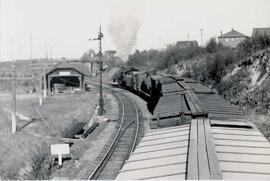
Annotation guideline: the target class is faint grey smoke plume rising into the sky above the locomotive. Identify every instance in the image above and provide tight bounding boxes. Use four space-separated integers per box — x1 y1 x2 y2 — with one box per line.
108 0 144 61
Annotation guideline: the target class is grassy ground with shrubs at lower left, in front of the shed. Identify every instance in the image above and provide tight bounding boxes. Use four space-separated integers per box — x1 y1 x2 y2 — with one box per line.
0 91 97 180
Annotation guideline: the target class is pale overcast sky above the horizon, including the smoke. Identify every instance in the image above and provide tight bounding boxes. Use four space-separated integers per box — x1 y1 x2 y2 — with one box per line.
0 0 270 61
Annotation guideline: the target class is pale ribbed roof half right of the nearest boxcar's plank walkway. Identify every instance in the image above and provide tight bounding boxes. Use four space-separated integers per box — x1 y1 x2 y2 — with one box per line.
211 122 270 180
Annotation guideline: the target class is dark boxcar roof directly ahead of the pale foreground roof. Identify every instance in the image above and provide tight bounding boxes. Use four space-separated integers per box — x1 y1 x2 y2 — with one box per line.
152 74 246 120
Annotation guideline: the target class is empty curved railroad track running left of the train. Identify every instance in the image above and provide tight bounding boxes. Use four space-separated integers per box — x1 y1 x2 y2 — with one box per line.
88 79 140 180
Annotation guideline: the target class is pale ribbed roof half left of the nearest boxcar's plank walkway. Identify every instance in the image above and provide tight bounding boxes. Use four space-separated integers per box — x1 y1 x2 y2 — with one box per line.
116 125 190 180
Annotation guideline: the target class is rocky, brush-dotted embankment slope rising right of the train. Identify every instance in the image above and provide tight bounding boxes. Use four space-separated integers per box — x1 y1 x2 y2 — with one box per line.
178 48 270 139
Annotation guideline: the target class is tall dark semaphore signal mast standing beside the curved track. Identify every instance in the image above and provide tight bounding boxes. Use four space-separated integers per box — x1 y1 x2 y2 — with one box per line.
89 26 104 115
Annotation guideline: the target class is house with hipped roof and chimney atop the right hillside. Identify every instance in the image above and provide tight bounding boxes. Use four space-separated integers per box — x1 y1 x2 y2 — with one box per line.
218 28 248 48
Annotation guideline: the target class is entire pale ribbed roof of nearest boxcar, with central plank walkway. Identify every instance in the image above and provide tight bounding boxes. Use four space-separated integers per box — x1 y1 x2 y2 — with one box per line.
116 119 270 180
